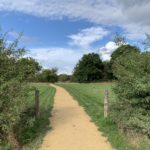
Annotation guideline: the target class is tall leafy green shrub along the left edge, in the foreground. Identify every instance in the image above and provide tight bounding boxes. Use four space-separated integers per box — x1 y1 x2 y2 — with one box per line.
0 32 26 148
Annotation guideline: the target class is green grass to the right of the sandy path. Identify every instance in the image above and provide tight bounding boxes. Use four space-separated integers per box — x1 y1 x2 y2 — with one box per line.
58 83 134 150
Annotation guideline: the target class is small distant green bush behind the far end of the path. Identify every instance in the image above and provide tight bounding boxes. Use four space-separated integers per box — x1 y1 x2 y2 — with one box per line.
37 68 58 83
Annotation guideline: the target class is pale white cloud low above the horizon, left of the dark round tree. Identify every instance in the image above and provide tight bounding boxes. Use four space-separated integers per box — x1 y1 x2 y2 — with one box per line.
26 47 90 74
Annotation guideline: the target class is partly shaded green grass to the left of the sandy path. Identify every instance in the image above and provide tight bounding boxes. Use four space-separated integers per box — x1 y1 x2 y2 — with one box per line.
16 83 55 150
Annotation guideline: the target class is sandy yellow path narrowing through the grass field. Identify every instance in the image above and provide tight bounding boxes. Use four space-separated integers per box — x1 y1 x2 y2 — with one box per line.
40 85 112 150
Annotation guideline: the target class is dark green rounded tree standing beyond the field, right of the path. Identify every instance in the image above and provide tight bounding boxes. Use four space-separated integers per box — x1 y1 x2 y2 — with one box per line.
73 53 103 82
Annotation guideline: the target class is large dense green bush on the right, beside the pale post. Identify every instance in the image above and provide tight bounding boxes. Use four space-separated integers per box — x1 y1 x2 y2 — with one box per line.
112 51 150 136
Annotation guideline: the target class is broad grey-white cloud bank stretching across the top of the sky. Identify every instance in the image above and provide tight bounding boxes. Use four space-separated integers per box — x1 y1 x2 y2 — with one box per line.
0 0 150 39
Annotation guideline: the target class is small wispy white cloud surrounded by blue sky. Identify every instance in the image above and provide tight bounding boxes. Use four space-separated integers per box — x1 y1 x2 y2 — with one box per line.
69 27 109 48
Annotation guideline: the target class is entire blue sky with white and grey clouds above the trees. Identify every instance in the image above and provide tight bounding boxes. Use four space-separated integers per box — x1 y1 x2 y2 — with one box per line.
0 0 150 74
